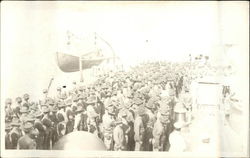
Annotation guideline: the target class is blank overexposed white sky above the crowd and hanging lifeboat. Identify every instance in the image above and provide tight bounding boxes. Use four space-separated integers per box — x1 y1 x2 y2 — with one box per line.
1 1 249 101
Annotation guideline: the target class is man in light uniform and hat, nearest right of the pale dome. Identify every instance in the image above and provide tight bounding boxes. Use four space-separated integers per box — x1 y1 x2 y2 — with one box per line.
113 118 126 151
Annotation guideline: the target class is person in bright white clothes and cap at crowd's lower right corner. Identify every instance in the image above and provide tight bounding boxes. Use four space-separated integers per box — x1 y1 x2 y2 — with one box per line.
169 121 187 152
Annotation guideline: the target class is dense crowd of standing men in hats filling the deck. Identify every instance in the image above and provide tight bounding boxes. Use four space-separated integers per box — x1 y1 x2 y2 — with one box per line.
5 62 232 151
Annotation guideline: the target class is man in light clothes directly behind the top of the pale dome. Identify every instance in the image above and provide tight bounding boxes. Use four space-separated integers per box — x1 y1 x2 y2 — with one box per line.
74 103 88 131
